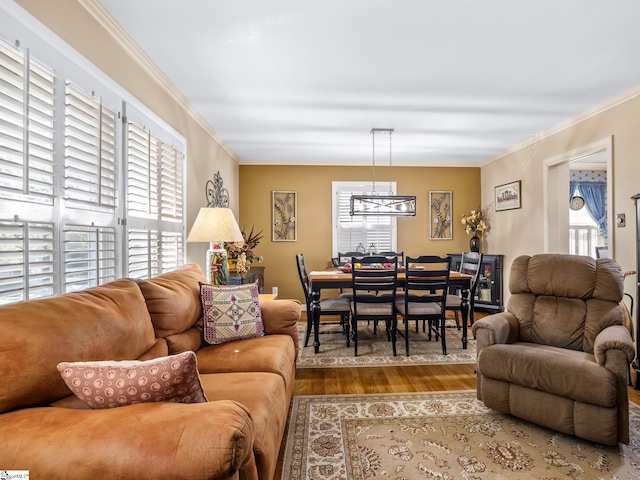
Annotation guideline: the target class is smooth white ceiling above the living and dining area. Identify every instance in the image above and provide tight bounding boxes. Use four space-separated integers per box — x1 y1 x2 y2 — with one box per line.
100 0 640 165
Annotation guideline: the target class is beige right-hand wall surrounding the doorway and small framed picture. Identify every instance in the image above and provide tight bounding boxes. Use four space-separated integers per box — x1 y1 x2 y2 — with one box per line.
482 94 640 304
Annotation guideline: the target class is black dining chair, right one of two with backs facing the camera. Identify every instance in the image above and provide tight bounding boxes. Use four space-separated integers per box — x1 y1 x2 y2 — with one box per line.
395 255 451 356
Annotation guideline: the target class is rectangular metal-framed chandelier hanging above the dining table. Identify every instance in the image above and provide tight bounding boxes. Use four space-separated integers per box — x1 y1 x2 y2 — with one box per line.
349 128 416 217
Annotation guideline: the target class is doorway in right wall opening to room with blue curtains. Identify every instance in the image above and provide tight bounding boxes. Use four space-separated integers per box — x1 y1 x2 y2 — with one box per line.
543 137 614 256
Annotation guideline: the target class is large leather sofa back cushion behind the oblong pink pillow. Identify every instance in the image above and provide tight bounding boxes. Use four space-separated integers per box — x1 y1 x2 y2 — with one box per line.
0 279 156 413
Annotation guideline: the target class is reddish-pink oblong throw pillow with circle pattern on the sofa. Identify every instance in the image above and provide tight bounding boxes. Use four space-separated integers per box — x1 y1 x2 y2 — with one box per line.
57 351 207 409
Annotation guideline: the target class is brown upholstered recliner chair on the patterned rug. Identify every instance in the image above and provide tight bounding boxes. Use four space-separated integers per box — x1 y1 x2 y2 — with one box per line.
473 254 634 445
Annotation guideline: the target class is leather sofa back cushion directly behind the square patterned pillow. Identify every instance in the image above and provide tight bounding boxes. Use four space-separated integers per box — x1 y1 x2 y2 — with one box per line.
136 263 206 337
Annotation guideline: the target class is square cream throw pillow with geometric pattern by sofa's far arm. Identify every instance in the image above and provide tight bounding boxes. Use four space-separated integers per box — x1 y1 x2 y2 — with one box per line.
200 283 264 344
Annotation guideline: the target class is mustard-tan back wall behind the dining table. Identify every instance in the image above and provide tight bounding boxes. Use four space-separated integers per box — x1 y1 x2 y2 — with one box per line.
238 165 480 300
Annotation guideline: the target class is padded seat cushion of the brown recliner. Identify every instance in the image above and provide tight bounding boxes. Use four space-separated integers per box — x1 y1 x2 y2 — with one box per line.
478 342 617 408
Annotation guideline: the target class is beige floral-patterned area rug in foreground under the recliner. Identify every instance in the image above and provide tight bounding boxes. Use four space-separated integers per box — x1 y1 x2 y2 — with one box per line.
282 391 640 480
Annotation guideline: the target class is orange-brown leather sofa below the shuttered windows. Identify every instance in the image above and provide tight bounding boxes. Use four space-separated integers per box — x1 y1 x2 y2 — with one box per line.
0 265 301 480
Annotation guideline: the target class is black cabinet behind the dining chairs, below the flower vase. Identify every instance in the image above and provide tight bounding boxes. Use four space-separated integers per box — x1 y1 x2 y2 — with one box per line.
447 253 504 313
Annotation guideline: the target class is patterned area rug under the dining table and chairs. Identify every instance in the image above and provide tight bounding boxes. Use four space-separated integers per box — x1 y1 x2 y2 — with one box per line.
297 320 476 368
